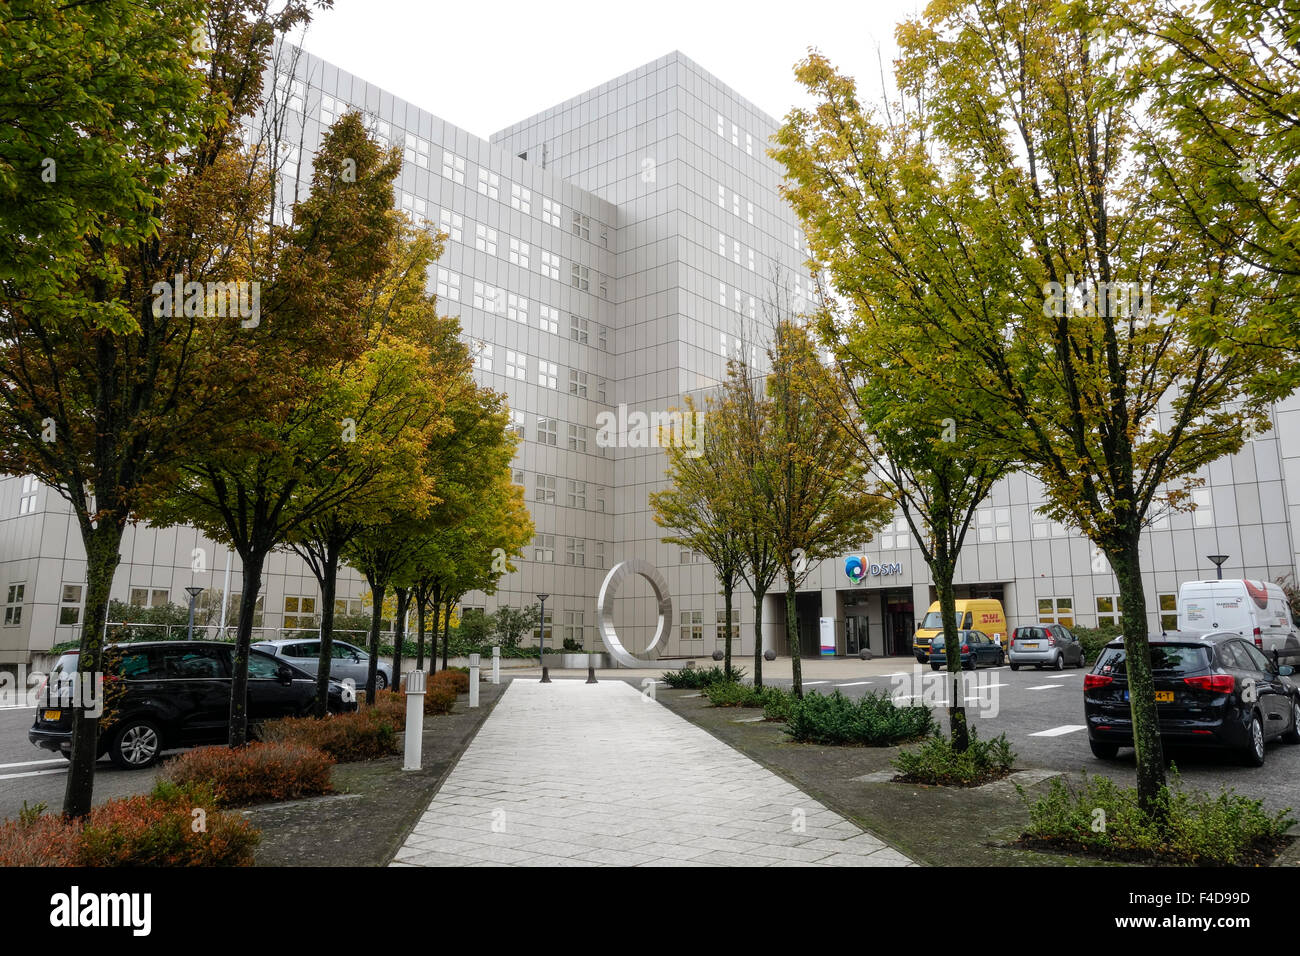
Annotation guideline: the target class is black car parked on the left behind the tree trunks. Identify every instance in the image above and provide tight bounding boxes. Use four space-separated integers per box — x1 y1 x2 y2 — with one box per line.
27 641 356 770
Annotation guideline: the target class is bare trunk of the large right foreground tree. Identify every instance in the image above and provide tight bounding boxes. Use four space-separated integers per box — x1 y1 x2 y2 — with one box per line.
1102 532 1165 814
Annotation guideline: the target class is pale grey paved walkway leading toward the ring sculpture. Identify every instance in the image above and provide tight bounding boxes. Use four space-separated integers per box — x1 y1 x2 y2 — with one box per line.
393 680 914 866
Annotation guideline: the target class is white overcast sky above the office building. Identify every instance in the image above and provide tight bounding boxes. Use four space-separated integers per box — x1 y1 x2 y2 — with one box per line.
300 0 924 138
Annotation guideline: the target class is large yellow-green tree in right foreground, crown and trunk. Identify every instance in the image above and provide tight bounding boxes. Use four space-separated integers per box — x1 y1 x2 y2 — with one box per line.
772 0 1295 809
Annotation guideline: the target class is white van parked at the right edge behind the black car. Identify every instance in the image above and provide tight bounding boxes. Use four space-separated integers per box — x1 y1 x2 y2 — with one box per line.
1178 579 1300 657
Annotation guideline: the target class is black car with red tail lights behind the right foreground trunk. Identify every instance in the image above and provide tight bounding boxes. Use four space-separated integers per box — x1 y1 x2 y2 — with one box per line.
1083 631 1300 766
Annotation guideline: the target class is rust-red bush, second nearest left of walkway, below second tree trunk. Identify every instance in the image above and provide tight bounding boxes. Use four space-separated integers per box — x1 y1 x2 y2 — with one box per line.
161 740 334 806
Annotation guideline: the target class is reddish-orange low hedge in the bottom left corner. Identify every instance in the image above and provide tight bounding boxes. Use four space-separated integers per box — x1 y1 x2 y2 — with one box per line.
0 787 259 866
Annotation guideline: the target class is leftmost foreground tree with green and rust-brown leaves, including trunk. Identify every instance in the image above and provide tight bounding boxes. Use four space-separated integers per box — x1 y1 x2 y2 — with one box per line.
0 0 325 817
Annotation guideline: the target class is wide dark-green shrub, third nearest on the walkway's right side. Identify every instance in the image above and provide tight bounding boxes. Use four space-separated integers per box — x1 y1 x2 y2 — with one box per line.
785 691 937 747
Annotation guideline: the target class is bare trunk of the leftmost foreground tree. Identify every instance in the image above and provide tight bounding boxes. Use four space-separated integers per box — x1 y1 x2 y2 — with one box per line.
64 519 124 819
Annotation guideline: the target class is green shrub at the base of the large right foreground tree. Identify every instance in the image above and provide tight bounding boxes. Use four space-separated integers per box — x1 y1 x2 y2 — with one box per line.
1017 770 1295 866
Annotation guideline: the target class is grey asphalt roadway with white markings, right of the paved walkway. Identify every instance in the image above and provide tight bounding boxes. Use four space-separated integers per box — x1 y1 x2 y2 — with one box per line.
759 658 1300 819
